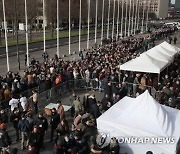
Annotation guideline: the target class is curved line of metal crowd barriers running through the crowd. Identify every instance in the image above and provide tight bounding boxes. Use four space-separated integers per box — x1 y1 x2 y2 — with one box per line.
0 79 159 112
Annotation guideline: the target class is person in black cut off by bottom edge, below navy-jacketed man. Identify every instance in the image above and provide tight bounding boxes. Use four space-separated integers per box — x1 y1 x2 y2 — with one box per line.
28 125 42 154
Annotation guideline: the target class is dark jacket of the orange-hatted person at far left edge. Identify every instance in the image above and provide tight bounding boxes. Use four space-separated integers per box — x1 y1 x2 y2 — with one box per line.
0 130 12 147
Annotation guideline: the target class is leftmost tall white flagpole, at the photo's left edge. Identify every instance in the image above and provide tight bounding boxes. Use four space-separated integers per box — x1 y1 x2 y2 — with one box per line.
2 0 9 72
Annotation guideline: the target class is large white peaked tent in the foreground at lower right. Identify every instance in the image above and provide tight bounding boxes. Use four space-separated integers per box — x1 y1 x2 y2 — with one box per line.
97 91 180 154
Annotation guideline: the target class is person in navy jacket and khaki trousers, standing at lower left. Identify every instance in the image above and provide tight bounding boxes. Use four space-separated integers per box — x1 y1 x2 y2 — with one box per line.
18 113 29 150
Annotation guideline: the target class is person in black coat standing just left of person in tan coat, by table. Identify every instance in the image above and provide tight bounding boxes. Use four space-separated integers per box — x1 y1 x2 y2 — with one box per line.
50 108 60 142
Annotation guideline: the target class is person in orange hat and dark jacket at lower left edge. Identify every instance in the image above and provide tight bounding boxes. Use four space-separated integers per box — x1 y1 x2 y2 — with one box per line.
0 123 12 153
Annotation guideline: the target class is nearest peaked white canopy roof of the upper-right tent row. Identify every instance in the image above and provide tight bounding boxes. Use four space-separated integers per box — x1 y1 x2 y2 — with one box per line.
120 53 167 74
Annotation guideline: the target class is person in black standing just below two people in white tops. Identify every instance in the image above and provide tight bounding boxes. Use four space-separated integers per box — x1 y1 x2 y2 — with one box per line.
10 108 21 142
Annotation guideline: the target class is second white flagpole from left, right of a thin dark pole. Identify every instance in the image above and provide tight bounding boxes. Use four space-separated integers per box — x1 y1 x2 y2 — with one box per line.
25 0 29 67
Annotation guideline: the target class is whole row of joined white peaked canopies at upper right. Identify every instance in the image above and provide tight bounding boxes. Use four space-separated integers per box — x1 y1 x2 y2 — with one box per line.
120 42 180 74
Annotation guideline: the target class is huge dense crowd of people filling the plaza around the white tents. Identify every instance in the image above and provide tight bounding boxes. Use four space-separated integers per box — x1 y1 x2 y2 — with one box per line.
0 25 180 154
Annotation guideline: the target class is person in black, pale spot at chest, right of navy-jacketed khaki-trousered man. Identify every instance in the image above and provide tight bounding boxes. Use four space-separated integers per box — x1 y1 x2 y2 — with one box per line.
35 112 48 146
